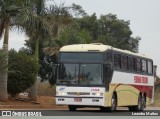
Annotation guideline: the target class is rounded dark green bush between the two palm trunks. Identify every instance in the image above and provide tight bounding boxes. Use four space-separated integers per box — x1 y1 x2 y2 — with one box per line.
7 50 37 96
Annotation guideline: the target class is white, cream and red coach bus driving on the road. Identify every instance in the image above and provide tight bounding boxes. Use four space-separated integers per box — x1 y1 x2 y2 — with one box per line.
56 43 154 111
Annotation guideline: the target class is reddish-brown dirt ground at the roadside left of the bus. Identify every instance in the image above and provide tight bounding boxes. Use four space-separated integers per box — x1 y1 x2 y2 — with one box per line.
0 96 67 109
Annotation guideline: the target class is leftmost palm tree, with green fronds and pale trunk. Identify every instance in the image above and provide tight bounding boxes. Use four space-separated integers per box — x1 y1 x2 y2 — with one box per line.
0 0 39 101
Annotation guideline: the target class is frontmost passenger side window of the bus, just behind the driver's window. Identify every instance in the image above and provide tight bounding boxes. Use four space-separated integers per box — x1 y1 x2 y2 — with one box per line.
114 54 121 69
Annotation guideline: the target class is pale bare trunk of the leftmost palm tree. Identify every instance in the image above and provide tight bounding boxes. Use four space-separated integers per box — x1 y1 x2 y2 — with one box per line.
0 18 10 101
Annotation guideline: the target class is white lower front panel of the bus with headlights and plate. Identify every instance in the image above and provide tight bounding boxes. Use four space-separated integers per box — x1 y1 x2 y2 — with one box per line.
56 86 105 106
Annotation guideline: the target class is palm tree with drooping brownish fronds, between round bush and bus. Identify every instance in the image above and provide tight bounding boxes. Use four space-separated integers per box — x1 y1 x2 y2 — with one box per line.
21 0 86 100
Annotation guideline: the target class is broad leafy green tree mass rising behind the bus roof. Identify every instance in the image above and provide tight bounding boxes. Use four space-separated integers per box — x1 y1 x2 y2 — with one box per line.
76 13 141 52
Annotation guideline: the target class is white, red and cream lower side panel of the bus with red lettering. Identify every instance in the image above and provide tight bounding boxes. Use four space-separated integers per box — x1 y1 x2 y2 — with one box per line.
105 71 154 107
